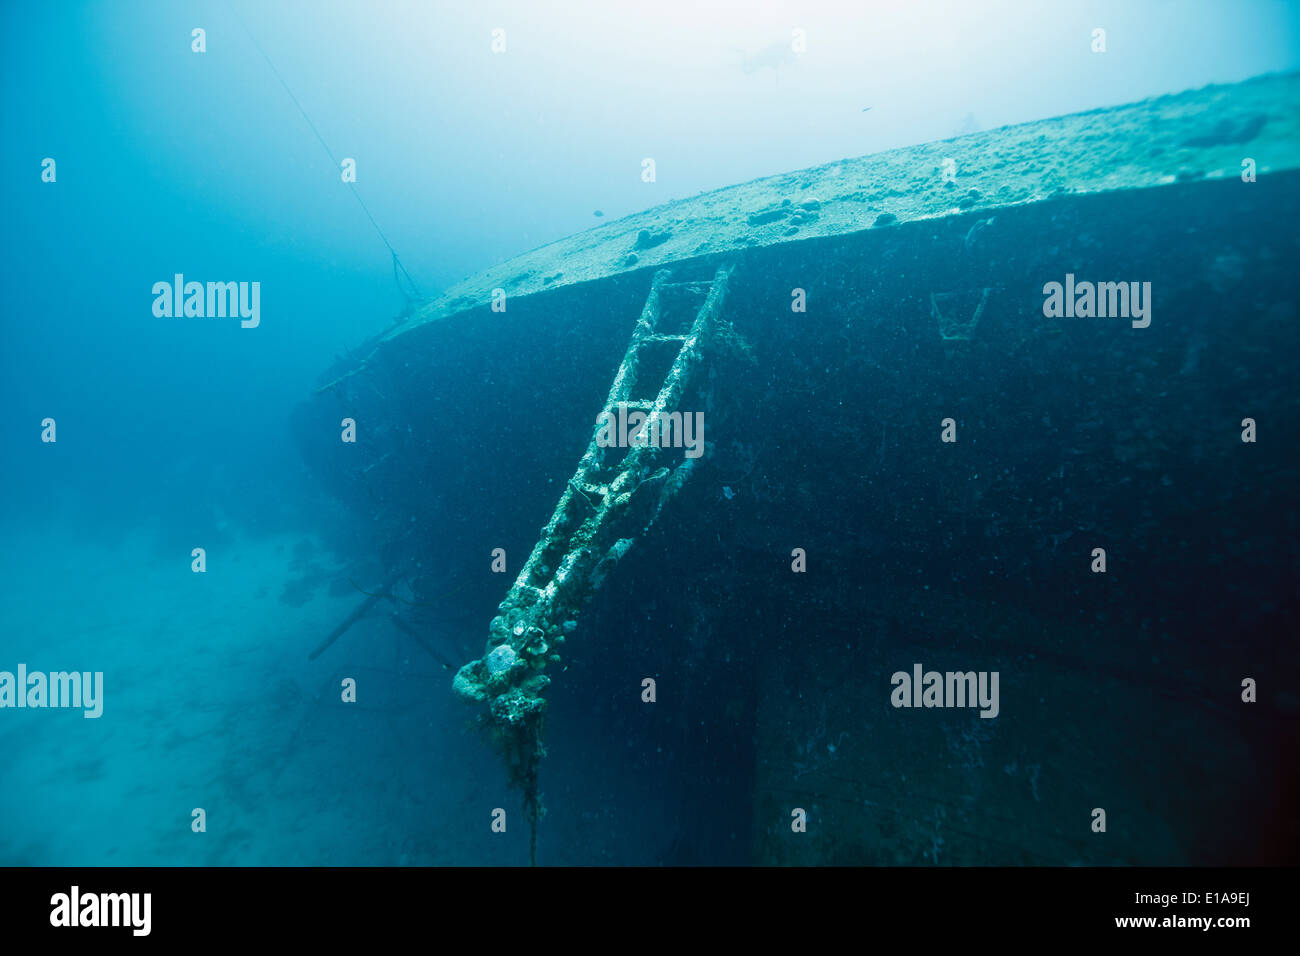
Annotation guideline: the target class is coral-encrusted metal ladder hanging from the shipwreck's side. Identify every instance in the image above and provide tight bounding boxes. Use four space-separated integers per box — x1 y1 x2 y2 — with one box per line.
454 265 732 858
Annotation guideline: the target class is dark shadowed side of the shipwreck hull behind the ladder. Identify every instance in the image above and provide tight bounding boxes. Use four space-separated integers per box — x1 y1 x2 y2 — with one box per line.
300 81 1300 865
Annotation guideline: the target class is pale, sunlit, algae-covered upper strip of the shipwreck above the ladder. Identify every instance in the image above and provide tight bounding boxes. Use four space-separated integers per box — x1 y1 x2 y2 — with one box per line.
321 73 1300 390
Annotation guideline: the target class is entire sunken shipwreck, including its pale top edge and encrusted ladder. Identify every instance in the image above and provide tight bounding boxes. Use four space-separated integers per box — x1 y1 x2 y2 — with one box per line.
304 75 1300 865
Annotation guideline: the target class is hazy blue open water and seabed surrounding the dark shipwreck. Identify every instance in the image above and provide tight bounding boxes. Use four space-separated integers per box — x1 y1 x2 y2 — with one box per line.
0 0 1300 865
